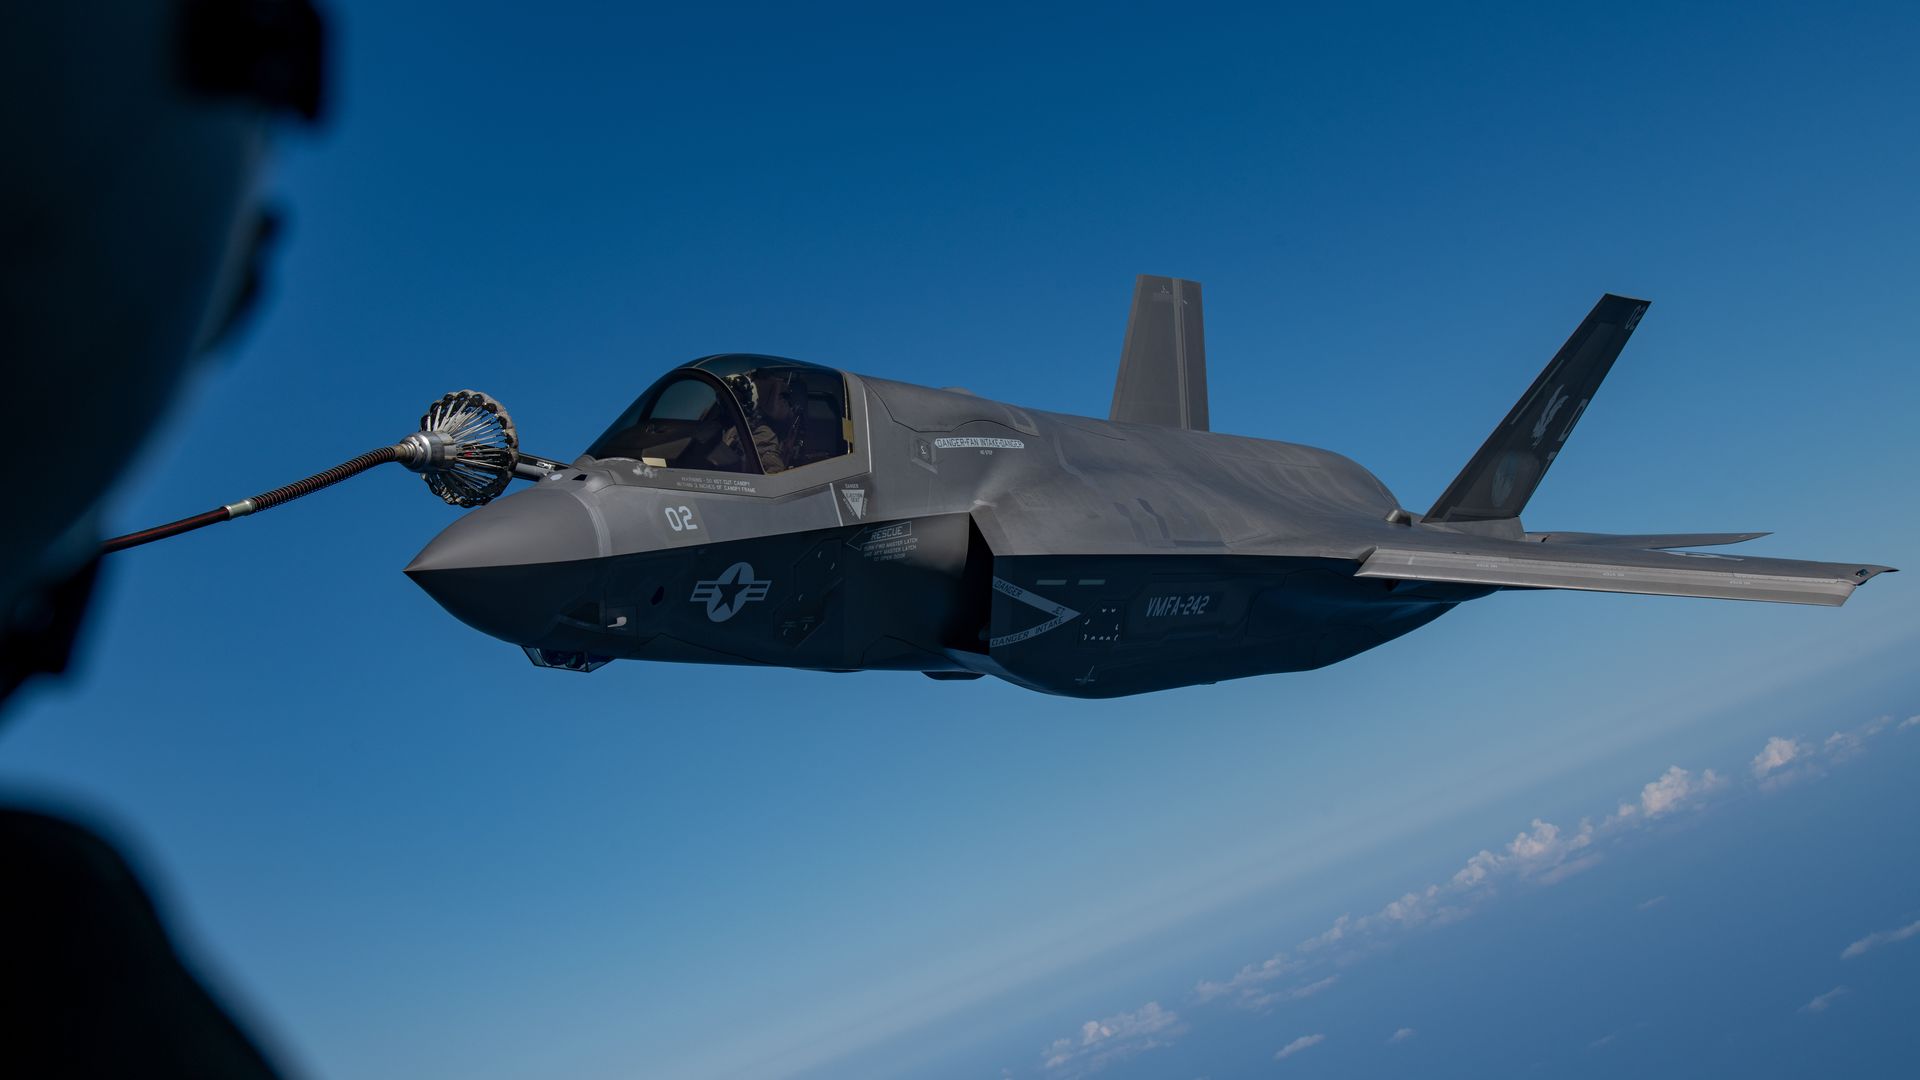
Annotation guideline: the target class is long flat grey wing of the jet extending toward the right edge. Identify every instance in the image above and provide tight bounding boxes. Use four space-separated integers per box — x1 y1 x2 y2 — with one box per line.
1357 540 1893 607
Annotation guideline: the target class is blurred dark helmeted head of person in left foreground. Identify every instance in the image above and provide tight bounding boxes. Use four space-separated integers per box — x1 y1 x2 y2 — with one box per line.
0 0 323 696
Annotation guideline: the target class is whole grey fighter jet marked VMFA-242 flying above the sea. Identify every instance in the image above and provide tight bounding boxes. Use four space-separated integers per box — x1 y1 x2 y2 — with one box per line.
407 277 1891 698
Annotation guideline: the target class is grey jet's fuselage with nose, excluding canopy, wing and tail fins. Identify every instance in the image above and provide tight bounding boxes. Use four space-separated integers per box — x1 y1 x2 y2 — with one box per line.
407 361 1490 698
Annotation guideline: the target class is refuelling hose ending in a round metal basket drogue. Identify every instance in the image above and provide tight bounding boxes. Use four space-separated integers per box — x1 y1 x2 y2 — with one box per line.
100 390 564 553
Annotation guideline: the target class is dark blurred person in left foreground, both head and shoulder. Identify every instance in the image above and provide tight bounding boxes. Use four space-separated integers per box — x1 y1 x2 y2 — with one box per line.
0 0 324 1080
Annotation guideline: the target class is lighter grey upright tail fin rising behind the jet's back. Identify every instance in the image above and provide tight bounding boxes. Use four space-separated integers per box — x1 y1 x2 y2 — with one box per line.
1108 273 1208 430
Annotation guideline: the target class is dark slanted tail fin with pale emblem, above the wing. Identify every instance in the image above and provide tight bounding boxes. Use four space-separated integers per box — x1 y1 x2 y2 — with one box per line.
1427 292 1647 523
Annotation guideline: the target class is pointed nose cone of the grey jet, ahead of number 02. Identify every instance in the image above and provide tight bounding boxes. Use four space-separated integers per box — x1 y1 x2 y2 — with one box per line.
405 486 601 646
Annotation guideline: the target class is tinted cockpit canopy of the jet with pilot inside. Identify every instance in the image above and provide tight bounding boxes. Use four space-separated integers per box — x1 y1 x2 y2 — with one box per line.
588 354 852 475
